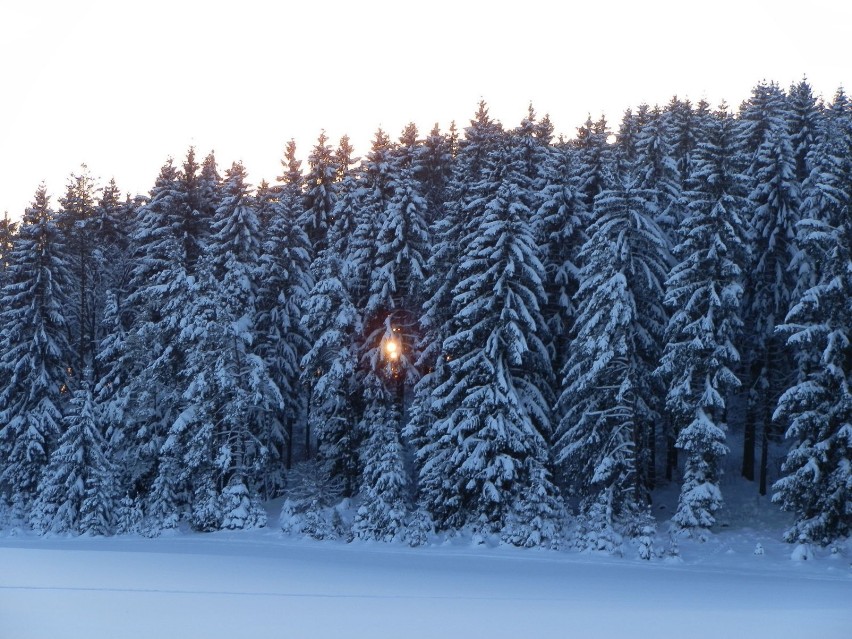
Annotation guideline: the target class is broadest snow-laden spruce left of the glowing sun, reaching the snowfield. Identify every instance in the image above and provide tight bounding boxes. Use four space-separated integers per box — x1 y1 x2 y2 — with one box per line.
174 163 276 529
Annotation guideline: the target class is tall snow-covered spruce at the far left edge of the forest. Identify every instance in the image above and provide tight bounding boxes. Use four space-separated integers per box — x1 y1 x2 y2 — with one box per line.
0 185 72 520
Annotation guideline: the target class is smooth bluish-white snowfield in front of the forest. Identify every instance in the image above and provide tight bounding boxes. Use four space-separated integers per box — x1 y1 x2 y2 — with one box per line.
0 529 852 639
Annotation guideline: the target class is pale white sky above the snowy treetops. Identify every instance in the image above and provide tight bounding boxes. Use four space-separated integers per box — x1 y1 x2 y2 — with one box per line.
0 0 852 217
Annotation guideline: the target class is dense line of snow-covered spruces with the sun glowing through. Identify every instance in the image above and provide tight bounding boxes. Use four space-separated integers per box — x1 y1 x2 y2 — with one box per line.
0 81 852 550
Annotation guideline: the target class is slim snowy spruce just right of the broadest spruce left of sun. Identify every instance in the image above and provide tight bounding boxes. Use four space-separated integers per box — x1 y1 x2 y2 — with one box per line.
258 140 313 480
